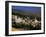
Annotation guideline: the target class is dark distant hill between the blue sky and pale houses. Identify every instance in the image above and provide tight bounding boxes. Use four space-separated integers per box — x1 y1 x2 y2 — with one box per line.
12 10 41 17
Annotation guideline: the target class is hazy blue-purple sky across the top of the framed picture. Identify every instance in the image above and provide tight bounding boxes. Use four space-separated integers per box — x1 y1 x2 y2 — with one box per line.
12 6 41 12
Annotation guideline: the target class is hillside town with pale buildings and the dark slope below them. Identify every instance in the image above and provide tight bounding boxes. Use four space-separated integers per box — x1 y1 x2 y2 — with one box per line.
12 15 41 30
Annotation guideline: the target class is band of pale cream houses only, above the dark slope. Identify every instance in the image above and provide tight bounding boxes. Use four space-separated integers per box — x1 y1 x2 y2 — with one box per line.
12 15 41 27
